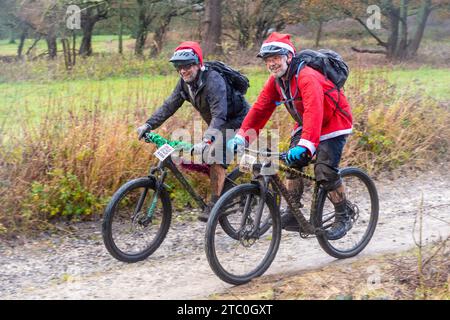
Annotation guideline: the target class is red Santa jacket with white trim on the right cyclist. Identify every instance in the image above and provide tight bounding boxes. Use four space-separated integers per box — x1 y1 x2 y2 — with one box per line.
238 66 353 155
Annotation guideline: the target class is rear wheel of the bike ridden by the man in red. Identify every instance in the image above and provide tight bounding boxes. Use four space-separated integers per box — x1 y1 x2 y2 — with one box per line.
314 168 379 259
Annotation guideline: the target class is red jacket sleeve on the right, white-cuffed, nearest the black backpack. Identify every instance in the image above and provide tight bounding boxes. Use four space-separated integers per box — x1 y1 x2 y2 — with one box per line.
298 75 324 155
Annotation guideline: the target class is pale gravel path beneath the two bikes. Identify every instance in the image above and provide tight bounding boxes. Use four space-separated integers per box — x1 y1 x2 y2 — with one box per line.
0 166 450 299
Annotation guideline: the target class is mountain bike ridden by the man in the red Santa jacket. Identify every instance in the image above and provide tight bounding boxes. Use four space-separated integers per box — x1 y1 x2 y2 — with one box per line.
205 148 379 285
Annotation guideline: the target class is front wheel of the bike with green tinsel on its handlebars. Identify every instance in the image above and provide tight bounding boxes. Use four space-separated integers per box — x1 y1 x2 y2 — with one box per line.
102 177 172 263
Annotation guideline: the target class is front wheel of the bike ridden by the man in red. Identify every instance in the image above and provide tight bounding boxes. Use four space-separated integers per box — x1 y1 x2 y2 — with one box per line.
205 184 281 285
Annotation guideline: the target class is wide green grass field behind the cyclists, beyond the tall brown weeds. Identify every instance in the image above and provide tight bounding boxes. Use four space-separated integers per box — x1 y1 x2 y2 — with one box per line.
0 67 450 132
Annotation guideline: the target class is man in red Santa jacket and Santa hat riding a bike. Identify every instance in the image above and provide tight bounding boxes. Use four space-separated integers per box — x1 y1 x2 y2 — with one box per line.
228 32 352 240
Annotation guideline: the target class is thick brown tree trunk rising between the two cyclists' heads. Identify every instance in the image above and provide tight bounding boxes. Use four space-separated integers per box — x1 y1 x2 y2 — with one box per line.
203 0 222 55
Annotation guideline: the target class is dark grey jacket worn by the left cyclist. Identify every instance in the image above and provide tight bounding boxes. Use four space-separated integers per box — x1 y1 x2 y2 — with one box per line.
147 69 250 139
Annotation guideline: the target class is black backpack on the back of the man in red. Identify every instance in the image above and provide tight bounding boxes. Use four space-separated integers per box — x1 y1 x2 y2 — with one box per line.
296 49 349 90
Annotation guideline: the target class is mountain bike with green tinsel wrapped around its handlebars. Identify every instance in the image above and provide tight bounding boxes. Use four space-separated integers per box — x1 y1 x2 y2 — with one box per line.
102 132 241 263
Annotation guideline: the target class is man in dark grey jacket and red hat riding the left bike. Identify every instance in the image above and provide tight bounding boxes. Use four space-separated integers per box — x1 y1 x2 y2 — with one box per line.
138 41 250 221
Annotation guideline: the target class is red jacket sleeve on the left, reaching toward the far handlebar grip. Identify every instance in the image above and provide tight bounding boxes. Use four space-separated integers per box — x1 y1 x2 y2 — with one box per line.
237 76 280 142
